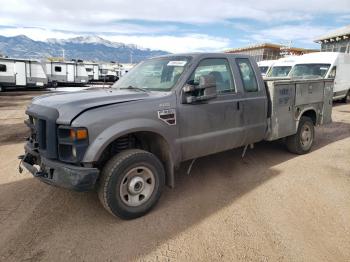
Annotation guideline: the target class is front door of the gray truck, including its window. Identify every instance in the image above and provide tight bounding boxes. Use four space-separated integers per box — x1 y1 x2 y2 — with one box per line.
178 58 243 160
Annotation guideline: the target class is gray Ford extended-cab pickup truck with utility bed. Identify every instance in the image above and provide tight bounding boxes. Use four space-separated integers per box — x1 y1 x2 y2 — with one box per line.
20 53 333 219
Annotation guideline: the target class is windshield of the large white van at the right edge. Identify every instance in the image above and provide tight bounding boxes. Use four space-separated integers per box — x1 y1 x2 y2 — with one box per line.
291 64 331 78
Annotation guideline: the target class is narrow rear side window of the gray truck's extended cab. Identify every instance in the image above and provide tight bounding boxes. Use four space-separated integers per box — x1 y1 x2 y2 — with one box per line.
236 58 258 92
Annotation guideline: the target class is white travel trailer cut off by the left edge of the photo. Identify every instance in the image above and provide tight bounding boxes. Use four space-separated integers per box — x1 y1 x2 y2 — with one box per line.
0 58 47 91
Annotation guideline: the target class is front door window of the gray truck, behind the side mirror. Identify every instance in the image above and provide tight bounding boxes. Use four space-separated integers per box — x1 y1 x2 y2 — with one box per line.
189 58 235 93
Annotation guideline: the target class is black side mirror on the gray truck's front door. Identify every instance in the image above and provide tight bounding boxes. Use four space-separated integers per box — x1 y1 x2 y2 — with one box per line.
183 75 217 104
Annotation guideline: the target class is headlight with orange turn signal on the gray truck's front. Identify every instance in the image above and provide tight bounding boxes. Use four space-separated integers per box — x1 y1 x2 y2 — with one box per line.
57 126 89 163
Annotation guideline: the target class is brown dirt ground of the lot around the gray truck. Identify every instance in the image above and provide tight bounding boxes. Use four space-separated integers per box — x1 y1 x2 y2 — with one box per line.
0 92 350 261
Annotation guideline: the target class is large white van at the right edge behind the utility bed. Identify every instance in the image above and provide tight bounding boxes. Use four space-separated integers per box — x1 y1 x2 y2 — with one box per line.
290 52 350 102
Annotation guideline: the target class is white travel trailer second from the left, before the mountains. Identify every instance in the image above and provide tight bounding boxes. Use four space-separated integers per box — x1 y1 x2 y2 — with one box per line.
45 61 89 87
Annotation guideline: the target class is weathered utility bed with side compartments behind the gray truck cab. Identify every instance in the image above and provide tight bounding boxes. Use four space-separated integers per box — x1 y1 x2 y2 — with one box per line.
265 79 334 141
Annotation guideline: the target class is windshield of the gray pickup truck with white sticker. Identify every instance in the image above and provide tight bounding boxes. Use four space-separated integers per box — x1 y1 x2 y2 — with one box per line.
112 56 190 91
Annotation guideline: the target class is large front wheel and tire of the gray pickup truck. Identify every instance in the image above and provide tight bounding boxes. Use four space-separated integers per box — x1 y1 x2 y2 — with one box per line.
98 149 165 219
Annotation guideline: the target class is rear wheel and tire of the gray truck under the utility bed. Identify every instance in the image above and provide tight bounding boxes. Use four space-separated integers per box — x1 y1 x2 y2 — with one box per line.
286 116 315 155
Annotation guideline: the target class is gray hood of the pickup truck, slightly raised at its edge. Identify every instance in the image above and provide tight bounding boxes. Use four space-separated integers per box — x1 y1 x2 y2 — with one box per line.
27 89 164 125
